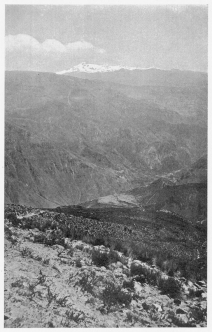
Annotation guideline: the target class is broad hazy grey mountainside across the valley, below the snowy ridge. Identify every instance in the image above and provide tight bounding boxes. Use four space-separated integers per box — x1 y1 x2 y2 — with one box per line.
5 72 207 207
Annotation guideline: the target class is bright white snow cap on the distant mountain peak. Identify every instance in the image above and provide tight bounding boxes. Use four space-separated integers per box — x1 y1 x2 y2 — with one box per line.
57 62 156 75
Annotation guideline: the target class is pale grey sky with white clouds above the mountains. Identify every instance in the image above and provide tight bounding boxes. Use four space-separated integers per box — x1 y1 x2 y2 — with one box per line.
5 5 208 72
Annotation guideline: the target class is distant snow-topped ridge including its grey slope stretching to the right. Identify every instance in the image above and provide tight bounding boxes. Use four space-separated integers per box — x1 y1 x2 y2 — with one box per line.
56 62 207 88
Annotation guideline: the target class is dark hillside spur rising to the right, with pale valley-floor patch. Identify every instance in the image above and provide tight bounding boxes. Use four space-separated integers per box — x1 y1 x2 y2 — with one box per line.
71 156 207 223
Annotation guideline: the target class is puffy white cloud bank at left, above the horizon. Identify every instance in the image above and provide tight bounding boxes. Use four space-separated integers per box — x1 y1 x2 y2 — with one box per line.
5 34 106 71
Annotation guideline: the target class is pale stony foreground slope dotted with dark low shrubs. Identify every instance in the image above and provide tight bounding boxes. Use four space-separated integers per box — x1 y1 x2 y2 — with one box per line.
4 205 207 328
